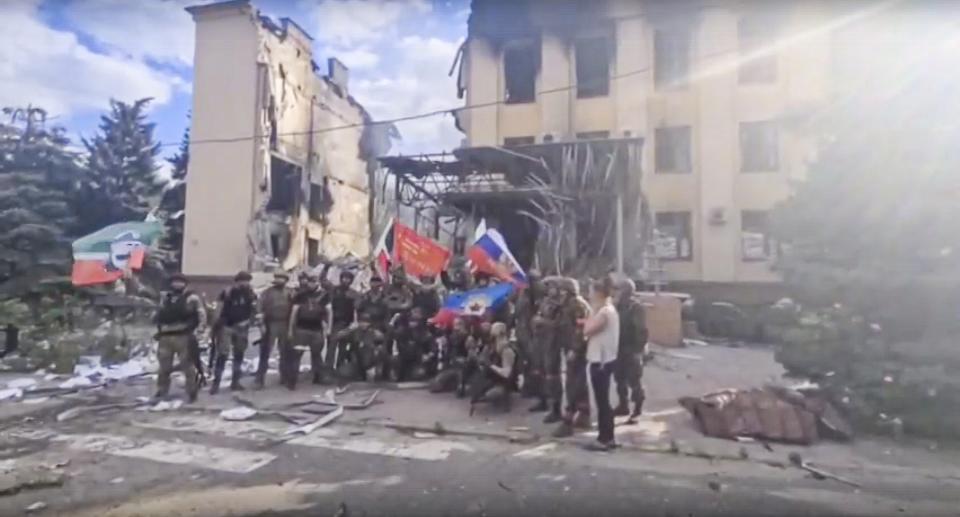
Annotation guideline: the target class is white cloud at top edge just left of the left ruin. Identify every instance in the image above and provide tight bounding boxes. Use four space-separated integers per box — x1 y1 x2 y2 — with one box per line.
64 0 205 66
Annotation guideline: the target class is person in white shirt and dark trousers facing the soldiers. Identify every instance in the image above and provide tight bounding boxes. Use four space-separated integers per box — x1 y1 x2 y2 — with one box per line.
583 277 620 451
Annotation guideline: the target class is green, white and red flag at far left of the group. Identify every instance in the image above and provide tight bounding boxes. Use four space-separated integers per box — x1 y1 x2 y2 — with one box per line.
71 221 163 286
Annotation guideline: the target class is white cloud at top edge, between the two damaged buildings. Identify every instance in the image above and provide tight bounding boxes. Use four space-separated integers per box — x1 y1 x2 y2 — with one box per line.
301 0 431 46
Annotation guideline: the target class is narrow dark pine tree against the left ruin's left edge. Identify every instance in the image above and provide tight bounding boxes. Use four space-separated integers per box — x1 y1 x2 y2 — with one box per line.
157 121 190 271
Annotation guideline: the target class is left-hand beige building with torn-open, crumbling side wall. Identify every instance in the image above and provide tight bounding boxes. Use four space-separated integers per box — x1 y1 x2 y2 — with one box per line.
183 0 386 283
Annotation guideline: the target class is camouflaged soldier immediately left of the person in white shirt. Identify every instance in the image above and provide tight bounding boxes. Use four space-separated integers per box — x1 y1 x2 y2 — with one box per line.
554 278 590 437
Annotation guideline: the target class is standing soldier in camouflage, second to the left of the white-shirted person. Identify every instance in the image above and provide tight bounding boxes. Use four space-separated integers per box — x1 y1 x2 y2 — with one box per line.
530 282 563 424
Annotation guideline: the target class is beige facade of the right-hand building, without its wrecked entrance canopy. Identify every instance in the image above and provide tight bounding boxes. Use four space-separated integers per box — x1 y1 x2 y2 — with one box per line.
458 0 831 283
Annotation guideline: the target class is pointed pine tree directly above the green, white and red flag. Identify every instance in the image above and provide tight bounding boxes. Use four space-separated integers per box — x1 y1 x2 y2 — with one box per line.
75 98 163 234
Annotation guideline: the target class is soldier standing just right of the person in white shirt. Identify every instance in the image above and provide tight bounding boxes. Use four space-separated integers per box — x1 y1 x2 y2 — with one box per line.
613 278 647 421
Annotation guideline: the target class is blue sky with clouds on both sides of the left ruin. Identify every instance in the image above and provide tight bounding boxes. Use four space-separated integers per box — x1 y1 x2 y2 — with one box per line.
0 0 469 175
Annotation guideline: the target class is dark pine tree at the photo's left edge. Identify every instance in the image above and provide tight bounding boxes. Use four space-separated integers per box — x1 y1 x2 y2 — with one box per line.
0 106 80 299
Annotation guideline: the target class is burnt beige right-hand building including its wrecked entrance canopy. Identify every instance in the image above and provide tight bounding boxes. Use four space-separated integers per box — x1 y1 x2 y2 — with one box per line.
387 0 831 286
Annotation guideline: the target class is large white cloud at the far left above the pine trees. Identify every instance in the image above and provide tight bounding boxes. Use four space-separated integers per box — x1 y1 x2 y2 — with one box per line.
0 0 187 115
